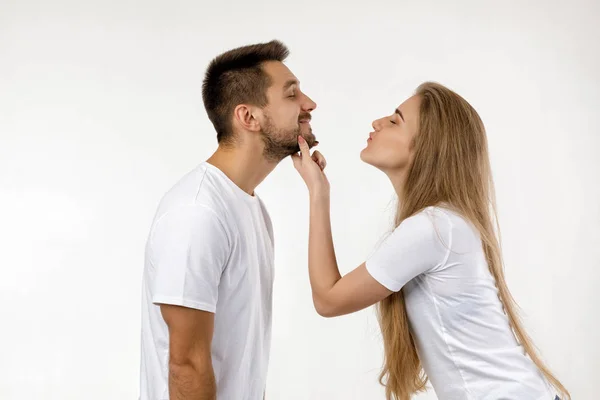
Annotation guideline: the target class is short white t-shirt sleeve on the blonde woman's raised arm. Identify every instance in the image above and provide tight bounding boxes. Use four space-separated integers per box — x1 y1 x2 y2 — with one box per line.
366 211 451 292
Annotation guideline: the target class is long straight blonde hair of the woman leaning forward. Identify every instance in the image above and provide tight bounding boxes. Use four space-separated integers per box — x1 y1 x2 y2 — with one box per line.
378 82 571 400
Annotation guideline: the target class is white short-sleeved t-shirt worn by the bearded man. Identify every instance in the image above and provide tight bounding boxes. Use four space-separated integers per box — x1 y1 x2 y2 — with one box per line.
140 162 274 400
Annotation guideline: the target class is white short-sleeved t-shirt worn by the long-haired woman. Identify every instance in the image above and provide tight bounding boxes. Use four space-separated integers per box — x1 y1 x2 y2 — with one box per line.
366 207 554 400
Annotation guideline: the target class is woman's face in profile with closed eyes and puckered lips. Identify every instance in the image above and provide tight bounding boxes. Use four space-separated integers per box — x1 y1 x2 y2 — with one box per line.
360 96 421 174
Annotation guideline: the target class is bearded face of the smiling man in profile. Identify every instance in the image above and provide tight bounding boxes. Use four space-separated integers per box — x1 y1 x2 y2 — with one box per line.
261 61 317 161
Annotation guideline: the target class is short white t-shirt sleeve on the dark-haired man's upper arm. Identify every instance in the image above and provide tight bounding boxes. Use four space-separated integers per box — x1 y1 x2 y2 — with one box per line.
150 206 230 313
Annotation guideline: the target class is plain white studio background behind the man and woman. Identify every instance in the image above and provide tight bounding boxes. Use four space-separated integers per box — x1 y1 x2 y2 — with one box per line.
0 0 600 400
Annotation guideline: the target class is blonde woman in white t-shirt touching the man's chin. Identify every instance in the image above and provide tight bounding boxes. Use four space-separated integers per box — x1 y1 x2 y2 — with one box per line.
292 83 570 400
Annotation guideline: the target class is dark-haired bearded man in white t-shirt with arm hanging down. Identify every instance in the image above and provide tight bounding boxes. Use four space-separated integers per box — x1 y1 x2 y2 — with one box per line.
140 41 319 400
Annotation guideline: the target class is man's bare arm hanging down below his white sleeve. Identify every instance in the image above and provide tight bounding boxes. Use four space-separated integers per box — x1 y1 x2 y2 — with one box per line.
160 304 217 400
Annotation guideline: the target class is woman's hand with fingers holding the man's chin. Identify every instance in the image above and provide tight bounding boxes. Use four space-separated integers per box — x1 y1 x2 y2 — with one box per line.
292 136 329 196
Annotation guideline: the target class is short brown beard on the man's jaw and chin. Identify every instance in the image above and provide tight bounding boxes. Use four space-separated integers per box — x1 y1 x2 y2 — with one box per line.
261 111 316 162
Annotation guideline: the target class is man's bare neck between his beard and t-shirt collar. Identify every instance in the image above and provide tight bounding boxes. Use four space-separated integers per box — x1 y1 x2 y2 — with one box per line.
206 146 279 196
